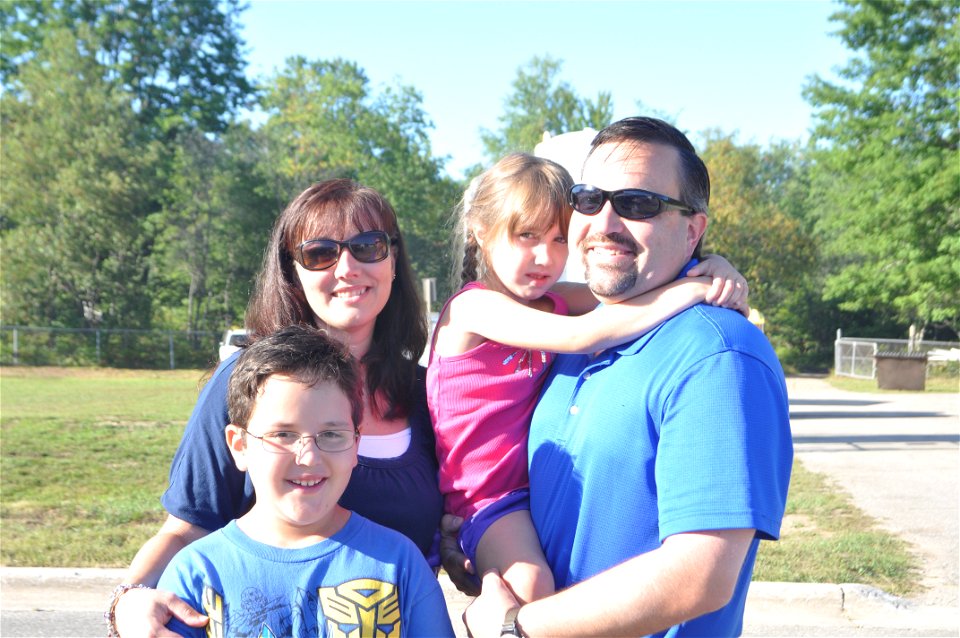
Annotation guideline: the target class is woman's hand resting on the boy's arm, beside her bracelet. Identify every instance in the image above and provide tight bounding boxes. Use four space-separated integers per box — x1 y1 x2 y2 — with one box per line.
114 589 207 638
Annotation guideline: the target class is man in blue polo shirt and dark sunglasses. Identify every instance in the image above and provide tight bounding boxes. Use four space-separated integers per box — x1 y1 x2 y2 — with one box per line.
465 118 793 638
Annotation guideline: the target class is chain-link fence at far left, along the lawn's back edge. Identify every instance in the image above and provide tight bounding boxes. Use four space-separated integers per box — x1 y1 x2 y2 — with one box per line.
0 326 220 370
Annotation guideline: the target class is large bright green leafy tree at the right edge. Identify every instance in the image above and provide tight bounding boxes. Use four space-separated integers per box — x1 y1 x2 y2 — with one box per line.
805 0 960 338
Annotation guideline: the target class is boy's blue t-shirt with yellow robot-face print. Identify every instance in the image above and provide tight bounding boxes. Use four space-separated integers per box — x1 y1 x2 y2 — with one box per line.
157 513 453 638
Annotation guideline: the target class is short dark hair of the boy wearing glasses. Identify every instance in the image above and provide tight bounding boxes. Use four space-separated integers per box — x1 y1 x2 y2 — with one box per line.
227 326 363 430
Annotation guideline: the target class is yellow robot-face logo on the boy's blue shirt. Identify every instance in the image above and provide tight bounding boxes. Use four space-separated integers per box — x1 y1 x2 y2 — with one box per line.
317 578 400 638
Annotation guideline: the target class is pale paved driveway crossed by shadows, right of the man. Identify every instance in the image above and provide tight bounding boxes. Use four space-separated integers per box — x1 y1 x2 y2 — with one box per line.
788 378 960 608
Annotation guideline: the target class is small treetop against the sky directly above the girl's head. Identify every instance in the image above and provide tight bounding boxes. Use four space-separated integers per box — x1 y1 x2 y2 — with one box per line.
480 56 613 162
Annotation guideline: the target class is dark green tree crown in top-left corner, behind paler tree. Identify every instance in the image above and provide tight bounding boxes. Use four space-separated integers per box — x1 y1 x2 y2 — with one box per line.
0 0 252 132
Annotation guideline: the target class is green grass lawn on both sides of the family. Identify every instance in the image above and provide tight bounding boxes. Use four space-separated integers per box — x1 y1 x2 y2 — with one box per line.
0 368 919 594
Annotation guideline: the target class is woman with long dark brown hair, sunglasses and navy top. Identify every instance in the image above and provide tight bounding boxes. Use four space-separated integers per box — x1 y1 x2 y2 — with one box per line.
108 179 442 634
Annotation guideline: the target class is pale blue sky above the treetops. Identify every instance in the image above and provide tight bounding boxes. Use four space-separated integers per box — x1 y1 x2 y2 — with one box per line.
242 0 852 177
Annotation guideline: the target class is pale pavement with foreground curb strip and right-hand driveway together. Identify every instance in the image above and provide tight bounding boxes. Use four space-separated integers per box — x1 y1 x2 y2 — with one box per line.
0 378 960 637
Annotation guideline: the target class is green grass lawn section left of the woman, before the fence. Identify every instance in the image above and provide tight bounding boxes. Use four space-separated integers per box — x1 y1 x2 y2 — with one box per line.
0 368 203 567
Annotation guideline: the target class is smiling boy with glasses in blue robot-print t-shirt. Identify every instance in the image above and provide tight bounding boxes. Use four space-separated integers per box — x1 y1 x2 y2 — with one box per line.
158 327 453 636
